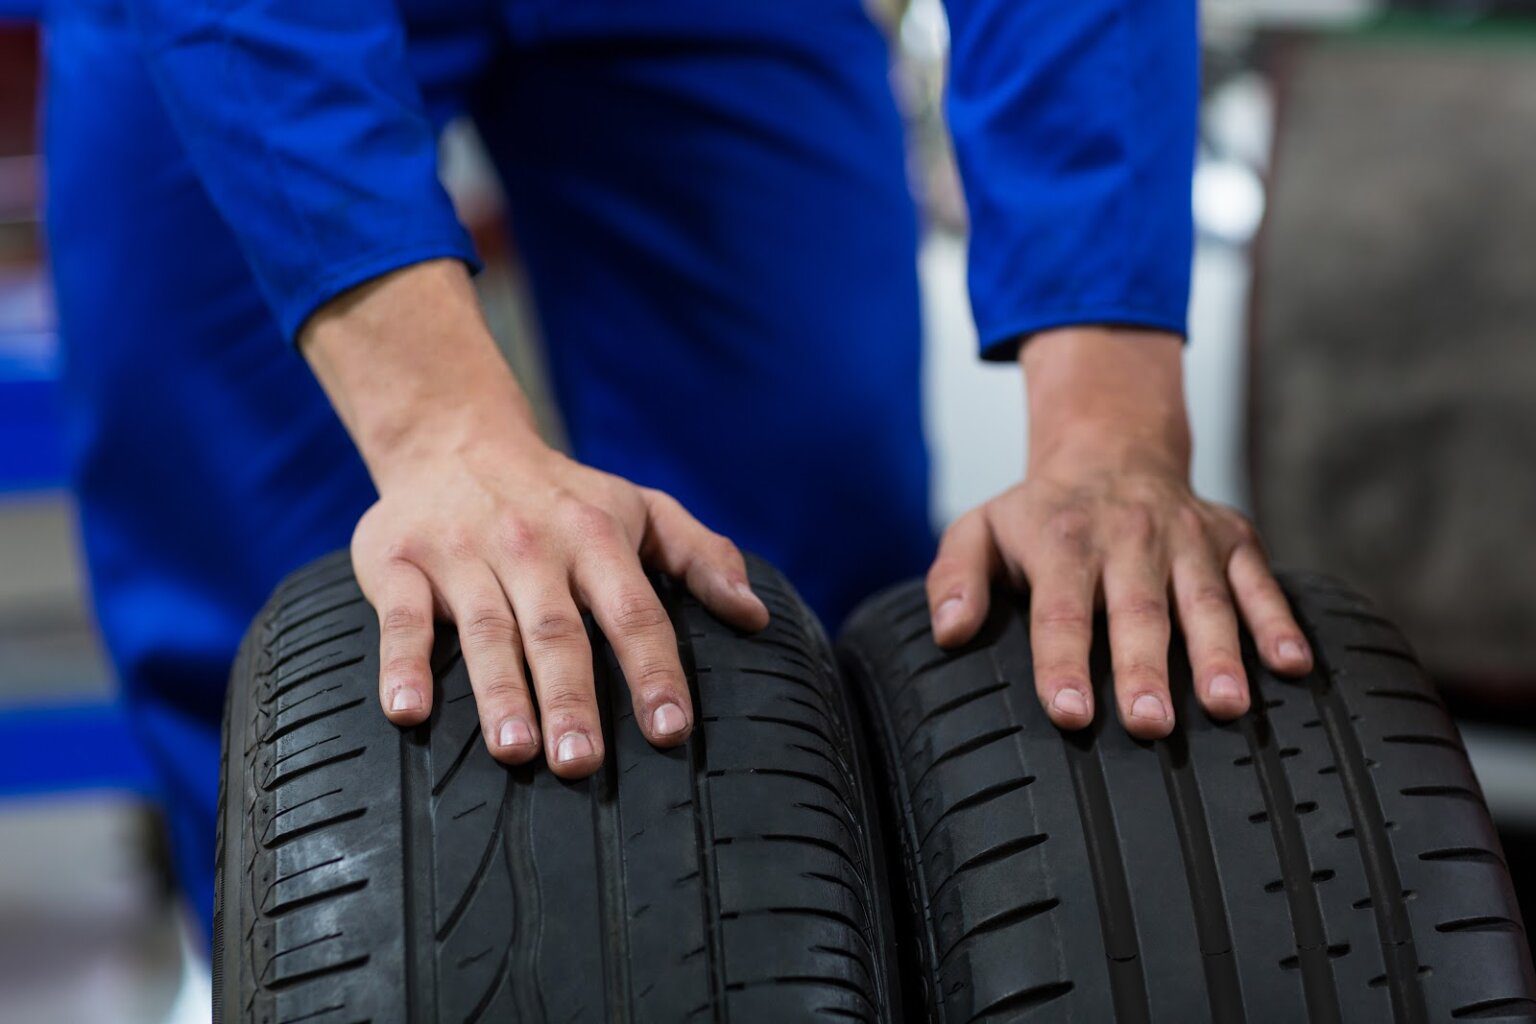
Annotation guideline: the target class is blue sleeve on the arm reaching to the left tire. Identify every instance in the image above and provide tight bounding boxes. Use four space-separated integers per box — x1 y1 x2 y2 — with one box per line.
123 0 475 339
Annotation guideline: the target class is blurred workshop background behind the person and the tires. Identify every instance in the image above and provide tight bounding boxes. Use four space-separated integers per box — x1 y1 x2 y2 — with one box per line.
0 0 1536 1024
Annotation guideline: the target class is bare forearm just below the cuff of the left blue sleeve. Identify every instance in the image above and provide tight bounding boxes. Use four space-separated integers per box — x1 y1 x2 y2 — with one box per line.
300 259 541 487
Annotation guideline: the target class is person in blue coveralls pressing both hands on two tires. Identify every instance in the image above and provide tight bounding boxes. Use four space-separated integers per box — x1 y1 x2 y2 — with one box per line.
48 0 1310 939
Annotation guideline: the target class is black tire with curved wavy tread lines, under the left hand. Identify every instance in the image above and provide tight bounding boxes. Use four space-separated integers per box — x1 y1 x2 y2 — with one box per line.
214 554 894 1024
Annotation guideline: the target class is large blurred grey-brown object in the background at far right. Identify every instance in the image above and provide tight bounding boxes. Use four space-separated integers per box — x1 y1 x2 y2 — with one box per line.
1252 28 1536 687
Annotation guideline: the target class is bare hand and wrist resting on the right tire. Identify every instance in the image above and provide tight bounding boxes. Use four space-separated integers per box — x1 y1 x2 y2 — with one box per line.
928 329 1312 738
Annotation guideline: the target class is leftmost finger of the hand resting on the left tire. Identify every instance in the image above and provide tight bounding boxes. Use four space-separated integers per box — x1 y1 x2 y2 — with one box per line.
373 562 432 726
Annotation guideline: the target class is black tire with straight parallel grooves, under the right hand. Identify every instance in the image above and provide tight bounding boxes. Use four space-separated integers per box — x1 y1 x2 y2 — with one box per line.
839 577 1536 1024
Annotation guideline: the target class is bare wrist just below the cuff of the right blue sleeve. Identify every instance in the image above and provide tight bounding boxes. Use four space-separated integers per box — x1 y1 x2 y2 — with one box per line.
1018 327 1190 474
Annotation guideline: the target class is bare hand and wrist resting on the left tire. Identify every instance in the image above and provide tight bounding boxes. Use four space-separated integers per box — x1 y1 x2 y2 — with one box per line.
301 263 768 778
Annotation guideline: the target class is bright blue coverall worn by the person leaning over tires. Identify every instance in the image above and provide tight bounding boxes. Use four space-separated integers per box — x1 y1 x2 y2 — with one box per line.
45 0 1197 939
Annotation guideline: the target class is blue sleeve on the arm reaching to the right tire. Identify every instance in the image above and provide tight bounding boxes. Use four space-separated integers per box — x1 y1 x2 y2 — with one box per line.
948 0 1200 359
